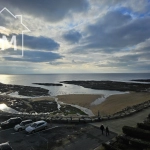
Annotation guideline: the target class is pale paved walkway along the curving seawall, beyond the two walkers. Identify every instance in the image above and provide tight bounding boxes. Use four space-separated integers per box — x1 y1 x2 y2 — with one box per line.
91 108 150 134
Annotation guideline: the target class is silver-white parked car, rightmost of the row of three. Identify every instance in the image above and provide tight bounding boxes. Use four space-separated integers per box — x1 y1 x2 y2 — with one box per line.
25 120 47 133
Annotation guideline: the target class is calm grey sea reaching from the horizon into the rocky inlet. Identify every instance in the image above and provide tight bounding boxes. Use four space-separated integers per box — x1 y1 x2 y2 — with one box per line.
0 73 150 97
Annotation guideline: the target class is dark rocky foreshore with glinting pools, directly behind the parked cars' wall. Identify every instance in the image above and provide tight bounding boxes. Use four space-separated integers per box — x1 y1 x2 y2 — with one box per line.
0 95 89 116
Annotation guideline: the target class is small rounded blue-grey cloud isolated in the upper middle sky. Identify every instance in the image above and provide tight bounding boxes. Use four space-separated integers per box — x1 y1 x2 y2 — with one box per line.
63 30 82 44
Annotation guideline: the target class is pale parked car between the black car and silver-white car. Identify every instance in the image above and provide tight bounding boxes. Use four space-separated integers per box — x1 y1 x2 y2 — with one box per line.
14 120 33 131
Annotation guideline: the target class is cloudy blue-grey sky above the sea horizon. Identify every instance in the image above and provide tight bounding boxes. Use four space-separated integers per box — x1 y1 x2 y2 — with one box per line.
0 0 150 74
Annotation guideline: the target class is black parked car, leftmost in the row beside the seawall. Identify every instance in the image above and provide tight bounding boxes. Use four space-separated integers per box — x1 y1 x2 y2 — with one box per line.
0 117 22 129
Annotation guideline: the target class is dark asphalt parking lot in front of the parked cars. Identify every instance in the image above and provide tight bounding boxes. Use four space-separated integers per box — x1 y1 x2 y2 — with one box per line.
0 124 116 150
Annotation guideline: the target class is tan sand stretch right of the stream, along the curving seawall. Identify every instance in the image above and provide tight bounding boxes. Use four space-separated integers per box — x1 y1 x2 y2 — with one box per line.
91 92 150 115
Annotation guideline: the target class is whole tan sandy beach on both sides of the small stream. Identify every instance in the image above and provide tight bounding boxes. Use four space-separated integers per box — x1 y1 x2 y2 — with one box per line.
57 92 150 115
